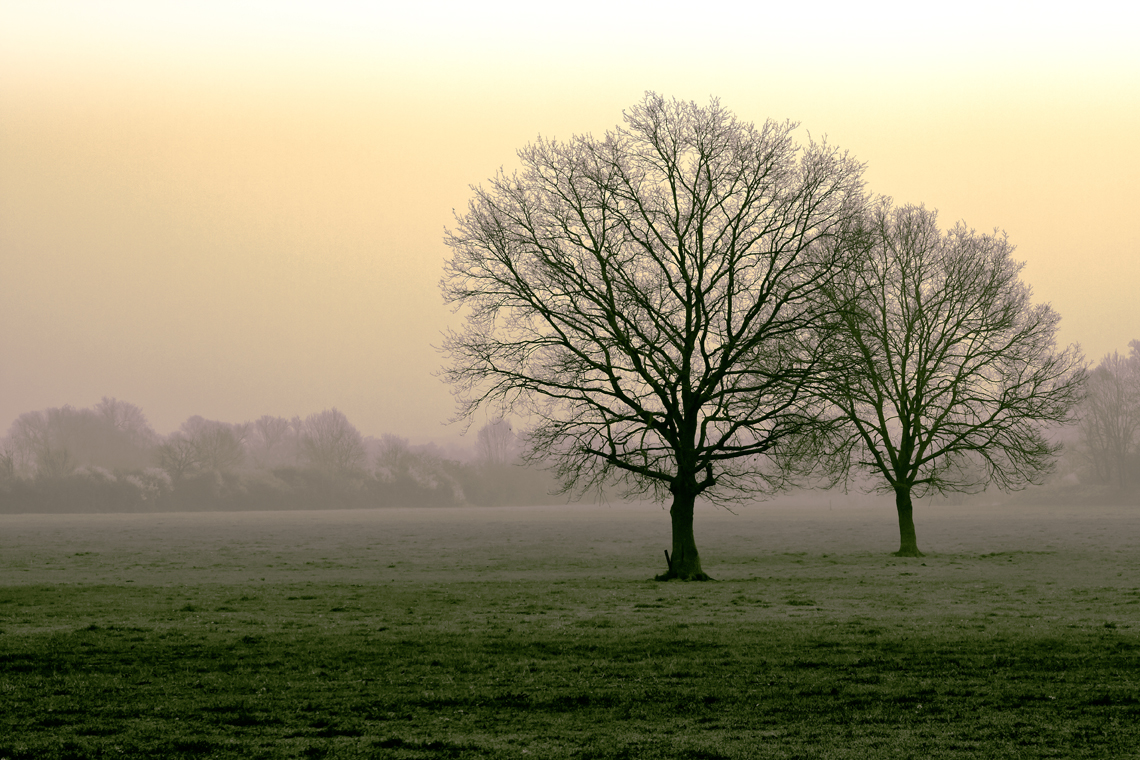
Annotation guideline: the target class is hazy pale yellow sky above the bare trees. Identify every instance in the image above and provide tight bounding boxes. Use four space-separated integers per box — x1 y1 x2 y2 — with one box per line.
0 0 1140 439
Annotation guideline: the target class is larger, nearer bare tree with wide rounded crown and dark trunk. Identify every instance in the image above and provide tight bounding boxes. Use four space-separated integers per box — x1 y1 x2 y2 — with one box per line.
441 93 863 579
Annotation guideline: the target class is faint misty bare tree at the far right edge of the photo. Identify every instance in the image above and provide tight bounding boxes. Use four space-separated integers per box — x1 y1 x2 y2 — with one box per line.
1081 348 1140 491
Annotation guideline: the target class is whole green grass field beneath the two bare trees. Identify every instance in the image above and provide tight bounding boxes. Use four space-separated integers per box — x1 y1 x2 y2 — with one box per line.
0 504 1140 760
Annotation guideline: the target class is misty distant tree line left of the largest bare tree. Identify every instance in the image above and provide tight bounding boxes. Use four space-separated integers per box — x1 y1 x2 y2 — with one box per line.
0 398 557 513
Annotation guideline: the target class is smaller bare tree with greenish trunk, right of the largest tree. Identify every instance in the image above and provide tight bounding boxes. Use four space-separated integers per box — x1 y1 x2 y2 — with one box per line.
821 201 1084 556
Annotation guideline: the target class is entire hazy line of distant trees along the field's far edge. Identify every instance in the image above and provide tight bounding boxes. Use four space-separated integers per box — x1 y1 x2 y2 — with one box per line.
0 340 1140 513
